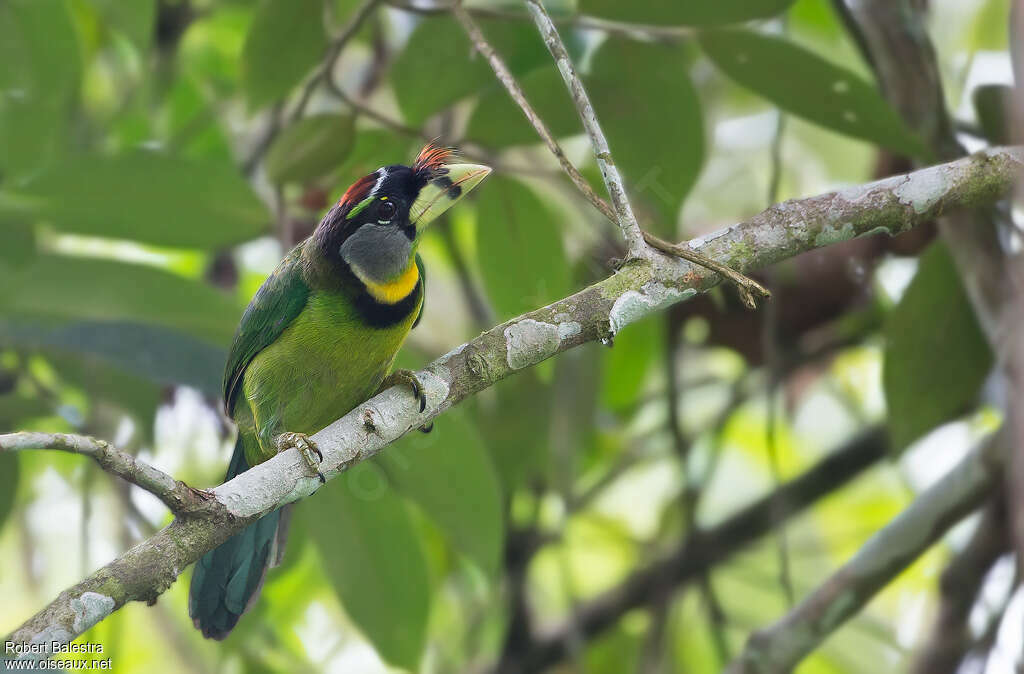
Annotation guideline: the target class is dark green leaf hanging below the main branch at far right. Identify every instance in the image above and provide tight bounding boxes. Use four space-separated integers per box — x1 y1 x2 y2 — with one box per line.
883 243 992 450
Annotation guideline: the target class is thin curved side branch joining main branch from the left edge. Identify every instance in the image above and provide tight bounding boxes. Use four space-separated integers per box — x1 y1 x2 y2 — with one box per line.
0 432 207 515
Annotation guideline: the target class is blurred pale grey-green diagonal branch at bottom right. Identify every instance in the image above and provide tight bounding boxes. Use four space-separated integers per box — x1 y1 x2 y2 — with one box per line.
726 432 1005 674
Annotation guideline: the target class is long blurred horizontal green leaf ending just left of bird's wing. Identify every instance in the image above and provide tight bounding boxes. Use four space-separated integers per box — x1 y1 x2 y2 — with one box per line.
0 255 242 344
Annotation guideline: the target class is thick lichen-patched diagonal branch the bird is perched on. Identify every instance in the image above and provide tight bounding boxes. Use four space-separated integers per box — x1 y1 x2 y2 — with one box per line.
8 148 1024 655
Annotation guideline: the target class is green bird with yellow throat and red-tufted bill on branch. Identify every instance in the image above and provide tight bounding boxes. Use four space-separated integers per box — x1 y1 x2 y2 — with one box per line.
188 142 490 639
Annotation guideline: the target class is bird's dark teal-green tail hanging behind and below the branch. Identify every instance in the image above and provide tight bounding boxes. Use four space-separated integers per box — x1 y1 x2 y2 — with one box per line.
188 437 287 639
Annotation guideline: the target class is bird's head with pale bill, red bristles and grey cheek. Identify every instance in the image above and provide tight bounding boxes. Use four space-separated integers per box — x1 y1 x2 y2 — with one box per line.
313 144 490 284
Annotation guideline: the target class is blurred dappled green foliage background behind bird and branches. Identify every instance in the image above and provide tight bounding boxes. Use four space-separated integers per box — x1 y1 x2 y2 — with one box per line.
0 0 1019 674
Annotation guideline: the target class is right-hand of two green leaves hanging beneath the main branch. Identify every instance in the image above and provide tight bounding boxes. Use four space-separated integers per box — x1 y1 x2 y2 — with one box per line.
378 411 505 576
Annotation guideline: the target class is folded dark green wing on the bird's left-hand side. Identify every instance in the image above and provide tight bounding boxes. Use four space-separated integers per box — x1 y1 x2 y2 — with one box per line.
224 244 310 409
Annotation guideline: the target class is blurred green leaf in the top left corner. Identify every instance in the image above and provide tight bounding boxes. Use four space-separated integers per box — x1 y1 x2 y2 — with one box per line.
0 0 81 177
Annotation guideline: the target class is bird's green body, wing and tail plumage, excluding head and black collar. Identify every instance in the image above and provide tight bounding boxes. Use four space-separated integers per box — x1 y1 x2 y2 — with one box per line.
189 242 424 638
